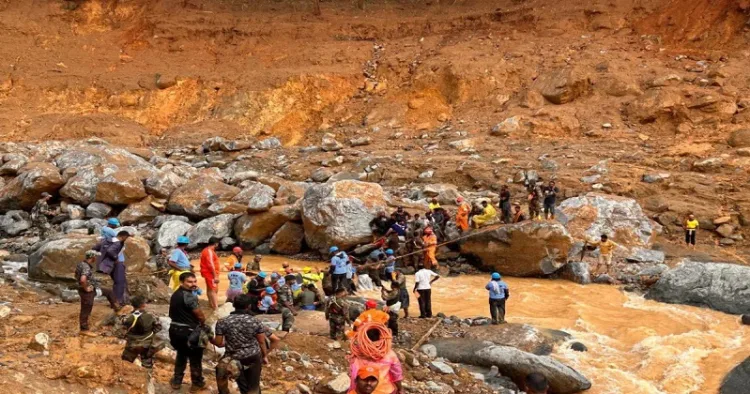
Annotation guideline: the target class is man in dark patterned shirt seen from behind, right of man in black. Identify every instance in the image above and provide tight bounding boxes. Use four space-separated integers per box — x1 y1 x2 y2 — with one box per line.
213 294 279 394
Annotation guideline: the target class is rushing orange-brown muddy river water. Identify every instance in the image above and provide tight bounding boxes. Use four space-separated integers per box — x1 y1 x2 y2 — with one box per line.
195 257 750 394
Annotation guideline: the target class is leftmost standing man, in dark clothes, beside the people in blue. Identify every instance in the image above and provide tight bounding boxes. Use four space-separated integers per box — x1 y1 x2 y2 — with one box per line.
75 250 120 337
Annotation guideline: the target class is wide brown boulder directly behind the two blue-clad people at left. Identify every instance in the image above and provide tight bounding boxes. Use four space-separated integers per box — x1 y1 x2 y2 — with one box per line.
29 235 151 280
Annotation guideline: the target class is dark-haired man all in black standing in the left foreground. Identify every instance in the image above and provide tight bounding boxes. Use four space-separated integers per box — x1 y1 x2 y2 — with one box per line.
169 272 206 392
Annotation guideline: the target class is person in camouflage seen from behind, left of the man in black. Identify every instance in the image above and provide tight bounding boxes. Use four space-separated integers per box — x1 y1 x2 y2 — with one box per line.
121 296 165 369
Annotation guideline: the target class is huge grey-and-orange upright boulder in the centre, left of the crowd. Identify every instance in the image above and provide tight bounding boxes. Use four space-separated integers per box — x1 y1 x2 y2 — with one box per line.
302 181 388 251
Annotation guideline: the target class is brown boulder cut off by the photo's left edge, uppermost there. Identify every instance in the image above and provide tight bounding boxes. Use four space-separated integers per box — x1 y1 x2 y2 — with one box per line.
0 163 65 212
